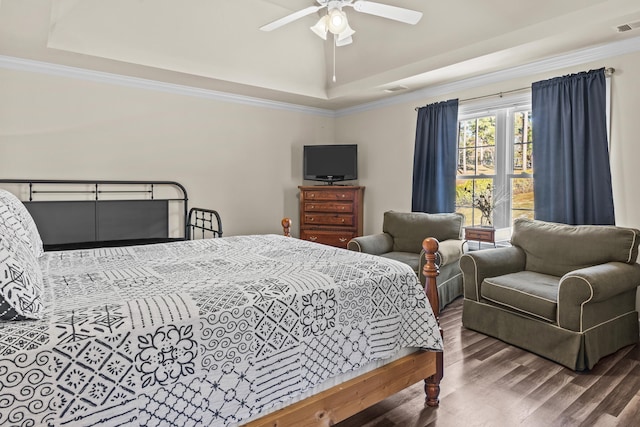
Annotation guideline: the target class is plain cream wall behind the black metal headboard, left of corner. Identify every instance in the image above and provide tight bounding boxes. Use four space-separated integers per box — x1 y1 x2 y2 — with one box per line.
0 69 334 239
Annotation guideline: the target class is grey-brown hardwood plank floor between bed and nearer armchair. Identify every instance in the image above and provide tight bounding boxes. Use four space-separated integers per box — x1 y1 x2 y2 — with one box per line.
336 299 640 427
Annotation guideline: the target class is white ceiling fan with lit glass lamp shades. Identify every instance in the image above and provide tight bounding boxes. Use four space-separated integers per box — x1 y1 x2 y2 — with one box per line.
260 0 422 46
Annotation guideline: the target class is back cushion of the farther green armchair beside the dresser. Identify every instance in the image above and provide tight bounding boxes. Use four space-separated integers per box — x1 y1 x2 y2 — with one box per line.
382 211 464 254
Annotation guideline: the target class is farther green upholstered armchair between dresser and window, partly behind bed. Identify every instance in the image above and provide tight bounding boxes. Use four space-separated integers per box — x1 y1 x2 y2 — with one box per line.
347 211 464 309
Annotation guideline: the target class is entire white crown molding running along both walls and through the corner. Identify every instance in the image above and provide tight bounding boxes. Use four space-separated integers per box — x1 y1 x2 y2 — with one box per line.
0 37 640 118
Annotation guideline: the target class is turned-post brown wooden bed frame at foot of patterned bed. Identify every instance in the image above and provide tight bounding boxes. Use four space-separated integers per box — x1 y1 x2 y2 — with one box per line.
245 218 443 427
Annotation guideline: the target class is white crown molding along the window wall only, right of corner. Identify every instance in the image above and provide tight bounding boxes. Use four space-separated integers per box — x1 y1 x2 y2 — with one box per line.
335 37 640 117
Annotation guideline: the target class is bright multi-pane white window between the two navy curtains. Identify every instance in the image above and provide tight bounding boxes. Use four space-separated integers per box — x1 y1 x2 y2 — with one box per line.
456 100 533 228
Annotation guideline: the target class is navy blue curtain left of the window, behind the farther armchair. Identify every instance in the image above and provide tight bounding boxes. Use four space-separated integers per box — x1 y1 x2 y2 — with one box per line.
411 99 458 213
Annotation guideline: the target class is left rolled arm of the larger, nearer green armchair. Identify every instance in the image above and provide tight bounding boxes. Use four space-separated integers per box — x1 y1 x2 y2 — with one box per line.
460 246 525 301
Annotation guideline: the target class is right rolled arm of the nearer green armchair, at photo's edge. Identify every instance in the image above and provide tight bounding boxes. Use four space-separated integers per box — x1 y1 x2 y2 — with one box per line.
558 262 640 332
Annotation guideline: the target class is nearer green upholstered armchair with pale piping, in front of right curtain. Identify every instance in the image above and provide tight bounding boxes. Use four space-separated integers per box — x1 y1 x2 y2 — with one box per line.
460 218 640 370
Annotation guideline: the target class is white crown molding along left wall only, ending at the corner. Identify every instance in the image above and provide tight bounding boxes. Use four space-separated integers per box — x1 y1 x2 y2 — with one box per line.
0 55 335 117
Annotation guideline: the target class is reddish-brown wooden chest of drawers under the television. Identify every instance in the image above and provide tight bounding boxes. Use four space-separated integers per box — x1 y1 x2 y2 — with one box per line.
298 185 364 248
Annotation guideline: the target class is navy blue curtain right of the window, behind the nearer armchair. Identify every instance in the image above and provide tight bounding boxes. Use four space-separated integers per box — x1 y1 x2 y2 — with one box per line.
531 68 615 225
